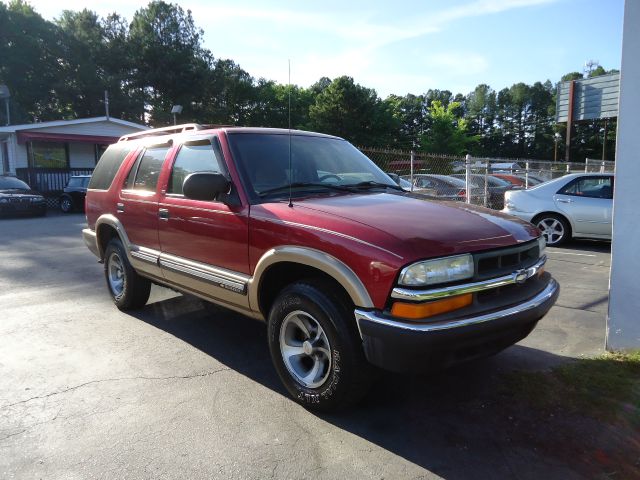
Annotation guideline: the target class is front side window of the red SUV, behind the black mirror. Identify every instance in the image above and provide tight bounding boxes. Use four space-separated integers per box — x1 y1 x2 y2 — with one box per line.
168 140 224 195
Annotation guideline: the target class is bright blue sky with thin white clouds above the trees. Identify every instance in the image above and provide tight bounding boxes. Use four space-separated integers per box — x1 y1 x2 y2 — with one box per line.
22 0 632 98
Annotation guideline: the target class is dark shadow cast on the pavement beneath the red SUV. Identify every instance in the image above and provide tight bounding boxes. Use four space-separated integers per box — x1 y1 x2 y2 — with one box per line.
133 296 608 480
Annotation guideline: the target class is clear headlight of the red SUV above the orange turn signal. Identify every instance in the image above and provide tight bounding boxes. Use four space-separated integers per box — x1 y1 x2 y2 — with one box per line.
398 254 474 287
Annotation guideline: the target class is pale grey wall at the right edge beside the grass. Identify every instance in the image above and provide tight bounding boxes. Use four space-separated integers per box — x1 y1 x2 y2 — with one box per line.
607 0 640 350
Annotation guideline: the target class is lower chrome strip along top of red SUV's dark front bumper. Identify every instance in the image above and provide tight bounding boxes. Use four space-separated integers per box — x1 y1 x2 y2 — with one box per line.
355 279 558 335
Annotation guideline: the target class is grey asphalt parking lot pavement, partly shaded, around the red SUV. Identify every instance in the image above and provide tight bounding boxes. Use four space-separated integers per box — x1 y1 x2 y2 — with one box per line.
0 214 610 479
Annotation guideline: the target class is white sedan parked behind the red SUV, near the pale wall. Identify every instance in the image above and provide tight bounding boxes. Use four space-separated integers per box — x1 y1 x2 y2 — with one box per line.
502 173 614 245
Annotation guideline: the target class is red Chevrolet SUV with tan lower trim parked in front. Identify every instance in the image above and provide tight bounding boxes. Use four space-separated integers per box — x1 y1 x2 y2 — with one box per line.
83 125 558 410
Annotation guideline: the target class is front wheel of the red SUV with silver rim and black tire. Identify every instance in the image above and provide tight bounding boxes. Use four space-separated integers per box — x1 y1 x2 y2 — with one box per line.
268 280 374 411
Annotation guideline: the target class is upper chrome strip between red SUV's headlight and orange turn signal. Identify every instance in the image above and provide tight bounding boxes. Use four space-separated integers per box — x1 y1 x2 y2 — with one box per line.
391 255 547 302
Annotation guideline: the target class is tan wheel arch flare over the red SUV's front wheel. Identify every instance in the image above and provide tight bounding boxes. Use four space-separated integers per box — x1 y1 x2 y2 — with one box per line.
248 245 374 312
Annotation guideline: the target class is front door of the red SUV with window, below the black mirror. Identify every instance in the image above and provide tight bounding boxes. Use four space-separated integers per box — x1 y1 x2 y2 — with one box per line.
158 136 249 306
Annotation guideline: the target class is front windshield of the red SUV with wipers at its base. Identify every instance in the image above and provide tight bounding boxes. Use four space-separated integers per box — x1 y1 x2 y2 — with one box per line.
229 133 398 201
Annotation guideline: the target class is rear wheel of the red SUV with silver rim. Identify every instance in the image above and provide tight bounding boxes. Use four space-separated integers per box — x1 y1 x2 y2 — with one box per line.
104 238 151 311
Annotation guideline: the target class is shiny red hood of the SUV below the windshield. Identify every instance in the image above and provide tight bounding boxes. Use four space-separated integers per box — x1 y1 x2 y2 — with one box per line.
295 193 539 259
